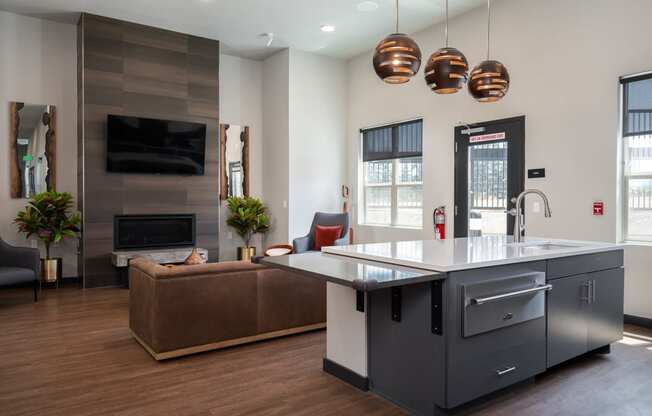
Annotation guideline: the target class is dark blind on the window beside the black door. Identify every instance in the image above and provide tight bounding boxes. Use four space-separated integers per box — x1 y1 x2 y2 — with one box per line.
362 120 423 162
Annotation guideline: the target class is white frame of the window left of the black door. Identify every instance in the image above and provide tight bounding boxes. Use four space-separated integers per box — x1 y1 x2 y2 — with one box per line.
357 117 424 230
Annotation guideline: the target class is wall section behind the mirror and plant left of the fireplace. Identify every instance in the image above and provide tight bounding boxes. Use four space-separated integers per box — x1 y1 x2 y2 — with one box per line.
0 12 77 277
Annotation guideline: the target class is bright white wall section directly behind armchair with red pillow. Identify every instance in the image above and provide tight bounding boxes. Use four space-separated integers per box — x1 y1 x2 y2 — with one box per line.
289 50 347 240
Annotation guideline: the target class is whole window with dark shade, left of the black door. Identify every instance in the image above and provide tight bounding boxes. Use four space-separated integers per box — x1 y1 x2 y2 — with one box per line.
360 120 423 227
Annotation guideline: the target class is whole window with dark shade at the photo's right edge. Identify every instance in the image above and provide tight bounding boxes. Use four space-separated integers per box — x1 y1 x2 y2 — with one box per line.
621 73 652 241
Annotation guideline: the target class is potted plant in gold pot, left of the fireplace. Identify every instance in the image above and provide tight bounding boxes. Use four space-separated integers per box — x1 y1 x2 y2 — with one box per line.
14 191 81 282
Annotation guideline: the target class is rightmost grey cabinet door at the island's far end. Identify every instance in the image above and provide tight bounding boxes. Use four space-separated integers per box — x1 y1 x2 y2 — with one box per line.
588 268 625 351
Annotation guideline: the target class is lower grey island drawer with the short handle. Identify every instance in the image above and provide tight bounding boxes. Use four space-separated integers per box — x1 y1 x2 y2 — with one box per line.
446 337 546 409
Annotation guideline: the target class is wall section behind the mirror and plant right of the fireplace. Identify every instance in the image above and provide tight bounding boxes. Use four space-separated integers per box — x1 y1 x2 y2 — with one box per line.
220 55 263 261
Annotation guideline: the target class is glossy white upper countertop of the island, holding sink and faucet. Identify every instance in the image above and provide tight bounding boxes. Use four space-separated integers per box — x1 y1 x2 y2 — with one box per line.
322 235 624 272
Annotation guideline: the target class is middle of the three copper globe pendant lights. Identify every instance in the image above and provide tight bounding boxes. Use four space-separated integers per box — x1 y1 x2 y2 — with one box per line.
424 0 469 94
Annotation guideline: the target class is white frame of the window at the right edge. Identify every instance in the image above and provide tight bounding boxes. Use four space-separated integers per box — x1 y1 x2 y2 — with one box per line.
618 71 652 244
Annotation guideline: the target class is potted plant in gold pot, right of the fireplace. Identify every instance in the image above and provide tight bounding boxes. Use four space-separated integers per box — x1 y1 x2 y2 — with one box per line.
226 196 269 260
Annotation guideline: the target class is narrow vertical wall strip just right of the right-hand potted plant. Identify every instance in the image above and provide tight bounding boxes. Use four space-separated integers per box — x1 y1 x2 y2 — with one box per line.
262 49 290 244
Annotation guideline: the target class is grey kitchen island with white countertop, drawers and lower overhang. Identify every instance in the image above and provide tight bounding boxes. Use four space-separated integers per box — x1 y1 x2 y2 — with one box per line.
262 236 624 415
